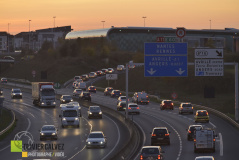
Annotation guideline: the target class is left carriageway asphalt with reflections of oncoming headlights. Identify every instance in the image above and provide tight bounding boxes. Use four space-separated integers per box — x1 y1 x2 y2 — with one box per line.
0 89 128 160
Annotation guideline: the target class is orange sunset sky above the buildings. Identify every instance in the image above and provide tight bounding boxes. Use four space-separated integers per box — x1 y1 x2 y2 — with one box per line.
0 0 239 35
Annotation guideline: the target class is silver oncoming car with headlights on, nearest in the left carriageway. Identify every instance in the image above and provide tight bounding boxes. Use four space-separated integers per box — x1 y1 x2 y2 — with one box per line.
86 131 107 148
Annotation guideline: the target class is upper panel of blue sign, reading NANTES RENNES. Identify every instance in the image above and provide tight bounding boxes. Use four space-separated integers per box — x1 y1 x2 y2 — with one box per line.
144 43 188 56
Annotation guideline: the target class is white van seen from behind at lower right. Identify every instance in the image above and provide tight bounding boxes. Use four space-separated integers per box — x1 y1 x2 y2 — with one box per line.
194 129 217 153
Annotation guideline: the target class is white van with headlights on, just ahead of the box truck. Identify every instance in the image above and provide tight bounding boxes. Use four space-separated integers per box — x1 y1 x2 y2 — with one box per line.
59 103 80 128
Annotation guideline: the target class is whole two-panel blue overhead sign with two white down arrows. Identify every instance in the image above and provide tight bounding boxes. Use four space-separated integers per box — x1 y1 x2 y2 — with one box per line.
144 43 188 77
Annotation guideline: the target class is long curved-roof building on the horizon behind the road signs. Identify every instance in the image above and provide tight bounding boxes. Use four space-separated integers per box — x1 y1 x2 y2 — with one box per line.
66 27 239 52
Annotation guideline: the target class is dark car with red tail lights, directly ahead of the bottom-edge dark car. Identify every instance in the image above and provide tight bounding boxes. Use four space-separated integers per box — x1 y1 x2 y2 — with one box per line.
150 127 170 146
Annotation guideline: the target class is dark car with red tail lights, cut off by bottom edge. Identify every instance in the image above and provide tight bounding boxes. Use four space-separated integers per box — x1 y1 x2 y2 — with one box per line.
140 146 164 160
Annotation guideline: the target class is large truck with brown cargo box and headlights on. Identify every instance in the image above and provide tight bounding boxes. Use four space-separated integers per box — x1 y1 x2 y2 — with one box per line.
32 82 56 107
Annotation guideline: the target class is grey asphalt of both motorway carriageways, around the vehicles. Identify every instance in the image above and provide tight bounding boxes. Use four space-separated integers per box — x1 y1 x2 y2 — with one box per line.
0 73 239 160
